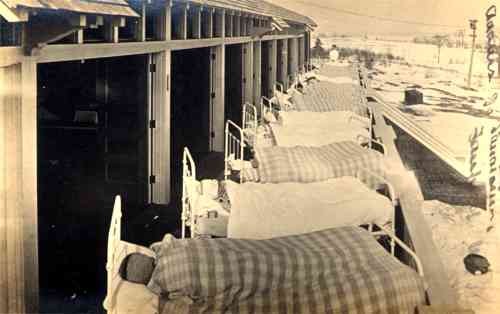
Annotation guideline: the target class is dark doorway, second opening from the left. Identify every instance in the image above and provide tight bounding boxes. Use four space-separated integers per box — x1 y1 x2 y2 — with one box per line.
171 48 211 198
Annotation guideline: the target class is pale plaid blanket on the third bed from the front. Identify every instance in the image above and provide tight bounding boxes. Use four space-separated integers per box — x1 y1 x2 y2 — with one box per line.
254 141 386 183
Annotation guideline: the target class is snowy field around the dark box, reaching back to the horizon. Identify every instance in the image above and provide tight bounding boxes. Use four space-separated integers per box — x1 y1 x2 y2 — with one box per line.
323 38 500 162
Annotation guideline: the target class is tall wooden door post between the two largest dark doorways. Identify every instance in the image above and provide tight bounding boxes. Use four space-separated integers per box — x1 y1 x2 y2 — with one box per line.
148 50 171 204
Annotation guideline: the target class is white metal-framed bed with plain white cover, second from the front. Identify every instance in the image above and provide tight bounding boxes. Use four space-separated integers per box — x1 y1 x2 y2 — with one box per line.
182 148 397 245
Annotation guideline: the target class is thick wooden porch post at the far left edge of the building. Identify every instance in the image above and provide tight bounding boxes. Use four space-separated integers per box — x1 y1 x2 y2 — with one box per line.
0 58 39 313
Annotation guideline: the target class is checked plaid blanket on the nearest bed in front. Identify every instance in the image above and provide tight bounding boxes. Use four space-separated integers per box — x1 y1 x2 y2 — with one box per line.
149 227 425 314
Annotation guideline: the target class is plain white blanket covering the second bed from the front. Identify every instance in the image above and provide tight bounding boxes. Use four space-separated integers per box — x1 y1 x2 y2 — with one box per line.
225 177 394 239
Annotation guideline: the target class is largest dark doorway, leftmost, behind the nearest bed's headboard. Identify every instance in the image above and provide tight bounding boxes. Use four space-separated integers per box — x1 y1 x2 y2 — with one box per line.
37 56 148 313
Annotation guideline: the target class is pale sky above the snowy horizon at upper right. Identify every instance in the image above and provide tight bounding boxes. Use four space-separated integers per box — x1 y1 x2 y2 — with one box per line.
267 0 500 35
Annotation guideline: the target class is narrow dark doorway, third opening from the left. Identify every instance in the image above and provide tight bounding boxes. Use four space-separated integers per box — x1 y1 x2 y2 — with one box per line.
224 45 243 125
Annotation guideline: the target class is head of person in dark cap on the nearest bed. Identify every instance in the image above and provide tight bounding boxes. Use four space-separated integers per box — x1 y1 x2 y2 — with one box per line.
119 253 155 285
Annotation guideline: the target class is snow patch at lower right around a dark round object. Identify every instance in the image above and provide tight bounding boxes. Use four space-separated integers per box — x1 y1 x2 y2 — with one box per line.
422 201 500 314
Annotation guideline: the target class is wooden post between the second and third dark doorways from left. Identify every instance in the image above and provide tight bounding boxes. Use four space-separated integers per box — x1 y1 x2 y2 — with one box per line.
210 45 226 152
